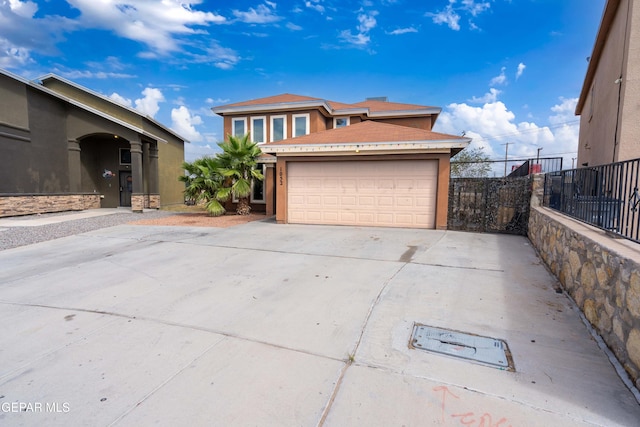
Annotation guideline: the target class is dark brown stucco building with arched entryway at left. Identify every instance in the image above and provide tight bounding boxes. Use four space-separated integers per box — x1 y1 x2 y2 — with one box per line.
0 70 185 216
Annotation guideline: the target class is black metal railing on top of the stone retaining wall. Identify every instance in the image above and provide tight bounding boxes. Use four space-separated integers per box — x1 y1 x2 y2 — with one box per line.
544 159 640 243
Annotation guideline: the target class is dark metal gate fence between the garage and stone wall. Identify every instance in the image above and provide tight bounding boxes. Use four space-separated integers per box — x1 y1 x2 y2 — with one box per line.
447 177 531 235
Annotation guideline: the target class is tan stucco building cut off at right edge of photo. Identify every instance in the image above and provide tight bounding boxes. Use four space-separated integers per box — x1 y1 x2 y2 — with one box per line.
576 0 640 167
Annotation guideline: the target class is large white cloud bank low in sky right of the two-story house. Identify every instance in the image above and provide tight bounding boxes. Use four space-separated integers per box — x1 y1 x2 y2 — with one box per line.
434 98 579 176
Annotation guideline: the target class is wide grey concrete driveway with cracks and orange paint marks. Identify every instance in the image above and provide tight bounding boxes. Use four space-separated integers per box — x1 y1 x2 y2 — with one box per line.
0 220 640 427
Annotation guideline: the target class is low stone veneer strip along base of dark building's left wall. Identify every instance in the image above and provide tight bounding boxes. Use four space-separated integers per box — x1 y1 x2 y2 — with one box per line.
0 193 100 217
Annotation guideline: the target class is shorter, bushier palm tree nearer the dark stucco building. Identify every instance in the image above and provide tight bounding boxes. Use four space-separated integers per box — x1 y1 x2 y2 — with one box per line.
178 157 226 216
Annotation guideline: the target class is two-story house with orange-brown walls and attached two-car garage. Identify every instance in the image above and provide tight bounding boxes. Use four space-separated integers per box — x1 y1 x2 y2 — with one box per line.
213 94 470 229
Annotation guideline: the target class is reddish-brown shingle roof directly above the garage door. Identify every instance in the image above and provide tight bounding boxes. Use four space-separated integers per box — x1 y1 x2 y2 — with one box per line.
265 121 468 146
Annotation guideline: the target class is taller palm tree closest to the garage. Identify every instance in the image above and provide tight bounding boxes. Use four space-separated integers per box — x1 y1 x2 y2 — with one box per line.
218 135 264 215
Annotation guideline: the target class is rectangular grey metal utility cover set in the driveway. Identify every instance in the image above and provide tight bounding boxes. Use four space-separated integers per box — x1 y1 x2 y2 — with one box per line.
409 324 513 369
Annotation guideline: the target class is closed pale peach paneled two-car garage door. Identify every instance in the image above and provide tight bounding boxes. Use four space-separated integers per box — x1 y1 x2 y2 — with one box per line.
287 160 438 228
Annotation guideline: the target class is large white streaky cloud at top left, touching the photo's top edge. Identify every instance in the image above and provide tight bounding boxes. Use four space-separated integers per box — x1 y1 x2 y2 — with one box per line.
68 0 226 53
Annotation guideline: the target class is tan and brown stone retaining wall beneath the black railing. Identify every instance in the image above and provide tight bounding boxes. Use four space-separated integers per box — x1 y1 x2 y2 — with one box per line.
529 176 640 387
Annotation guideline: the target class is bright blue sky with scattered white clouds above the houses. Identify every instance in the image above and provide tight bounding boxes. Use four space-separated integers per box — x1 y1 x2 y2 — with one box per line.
0 0 605 171
